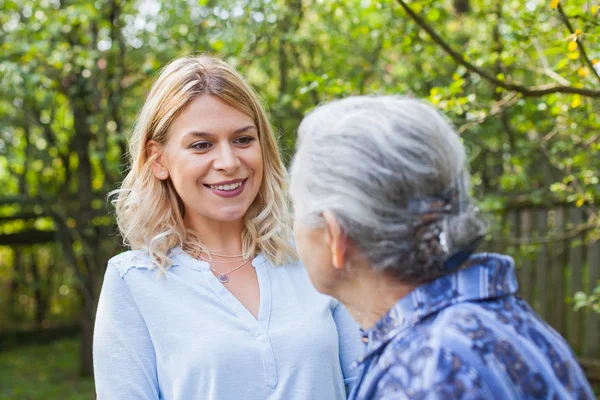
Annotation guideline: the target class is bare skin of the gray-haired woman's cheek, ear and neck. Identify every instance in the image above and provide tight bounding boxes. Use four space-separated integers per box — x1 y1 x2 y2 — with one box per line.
294 211 416 330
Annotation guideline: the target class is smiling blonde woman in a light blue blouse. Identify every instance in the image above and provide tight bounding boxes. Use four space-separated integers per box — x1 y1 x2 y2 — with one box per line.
94 56 361 400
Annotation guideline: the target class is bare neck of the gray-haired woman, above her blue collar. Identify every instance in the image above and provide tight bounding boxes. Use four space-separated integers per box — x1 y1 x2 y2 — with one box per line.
334 265 418 330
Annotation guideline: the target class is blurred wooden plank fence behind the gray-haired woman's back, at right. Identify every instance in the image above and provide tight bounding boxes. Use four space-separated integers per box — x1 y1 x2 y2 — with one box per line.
482 206 600 368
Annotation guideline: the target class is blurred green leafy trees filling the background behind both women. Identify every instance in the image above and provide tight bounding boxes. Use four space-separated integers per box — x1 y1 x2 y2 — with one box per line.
0 0 600 374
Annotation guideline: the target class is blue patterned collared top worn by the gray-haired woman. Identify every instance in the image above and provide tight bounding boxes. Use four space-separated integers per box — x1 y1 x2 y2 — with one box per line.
349 254 594 400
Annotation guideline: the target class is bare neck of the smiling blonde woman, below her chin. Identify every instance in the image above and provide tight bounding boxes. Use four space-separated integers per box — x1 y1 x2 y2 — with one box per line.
184 215 244 254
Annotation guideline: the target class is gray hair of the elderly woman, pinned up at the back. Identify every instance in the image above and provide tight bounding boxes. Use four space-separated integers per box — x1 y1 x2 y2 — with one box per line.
290 96 487 283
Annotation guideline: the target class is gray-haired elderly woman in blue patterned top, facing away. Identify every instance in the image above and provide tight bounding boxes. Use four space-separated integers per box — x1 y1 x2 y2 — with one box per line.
291 97 593 400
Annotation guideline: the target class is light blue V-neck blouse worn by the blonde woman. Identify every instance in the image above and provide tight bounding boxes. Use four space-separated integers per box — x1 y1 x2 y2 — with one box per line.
94 248 363 400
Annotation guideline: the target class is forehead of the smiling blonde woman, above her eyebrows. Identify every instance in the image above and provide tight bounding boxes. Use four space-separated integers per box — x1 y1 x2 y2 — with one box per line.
169 95 256 139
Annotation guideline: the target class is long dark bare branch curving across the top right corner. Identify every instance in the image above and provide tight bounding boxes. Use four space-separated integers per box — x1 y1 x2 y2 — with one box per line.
397 0 600 98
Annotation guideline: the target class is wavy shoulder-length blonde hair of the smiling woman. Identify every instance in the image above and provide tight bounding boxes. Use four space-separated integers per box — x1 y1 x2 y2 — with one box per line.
110 55 297 272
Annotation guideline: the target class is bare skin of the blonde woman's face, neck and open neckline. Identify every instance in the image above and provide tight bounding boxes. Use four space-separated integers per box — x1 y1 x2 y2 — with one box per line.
147 95 263 317
